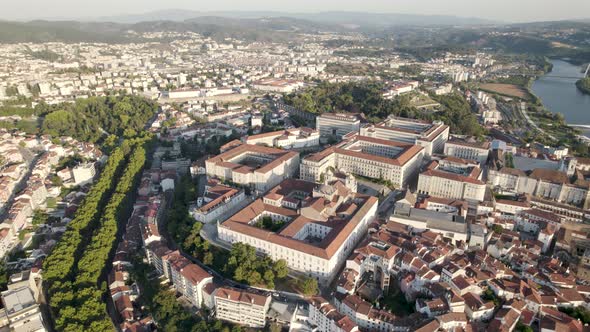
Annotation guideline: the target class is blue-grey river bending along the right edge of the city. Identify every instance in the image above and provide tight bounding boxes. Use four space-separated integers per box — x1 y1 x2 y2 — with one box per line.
532 60 590 137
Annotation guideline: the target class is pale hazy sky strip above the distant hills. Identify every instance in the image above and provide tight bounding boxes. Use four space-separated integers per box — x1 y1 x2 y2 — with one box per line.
0 0 590 22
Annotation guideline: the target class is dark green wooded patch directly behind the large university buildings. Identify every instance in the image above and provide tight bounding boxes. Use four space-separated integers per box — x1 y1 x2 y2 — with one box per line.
285 82 484 136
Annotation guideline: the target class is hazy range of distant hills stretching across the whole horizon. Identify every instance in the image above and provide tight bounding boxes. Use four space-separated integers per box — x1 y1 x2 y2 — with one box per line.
0 10 590 49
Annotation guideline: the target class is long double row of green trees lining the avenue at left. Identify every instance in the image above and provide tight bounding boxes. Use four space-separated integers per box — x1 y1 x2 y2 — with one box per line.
43 136 149 331
